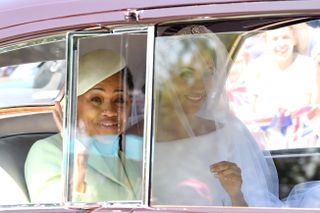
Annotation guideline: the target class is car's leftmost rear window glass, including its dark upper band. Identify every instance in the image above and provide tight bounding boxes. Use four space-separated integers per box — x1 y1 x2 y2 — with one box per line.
0 38 66 108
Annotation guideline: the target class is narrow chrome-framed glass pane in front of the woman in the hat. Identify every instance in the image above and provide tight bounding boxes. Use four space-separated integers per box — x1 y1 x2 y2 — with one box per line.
69 32 147 202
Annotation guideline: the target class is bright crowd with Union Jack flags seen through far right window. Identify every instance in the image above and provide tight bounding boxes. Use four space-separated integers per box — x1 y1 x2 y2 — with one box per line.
228 23 320 149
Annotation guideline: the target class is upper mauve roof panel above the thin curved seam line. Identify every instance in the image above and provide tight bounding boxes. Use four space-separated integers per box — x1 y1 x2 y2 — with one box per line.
0 0 238 29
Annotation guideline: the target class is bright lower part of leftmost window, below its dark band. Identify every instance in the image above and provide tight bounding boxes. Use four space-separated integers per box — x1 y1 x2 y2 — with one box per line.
0 60 65 107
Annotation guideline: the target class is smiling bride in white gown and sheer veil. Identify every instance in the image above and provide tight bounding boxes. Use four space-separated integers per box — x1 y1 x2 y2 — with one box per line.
152 25 278 206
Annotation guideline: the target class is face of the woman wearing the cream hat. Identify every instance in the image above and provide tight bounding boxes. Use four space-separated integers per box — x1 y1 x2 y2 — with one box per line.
78 73 132 136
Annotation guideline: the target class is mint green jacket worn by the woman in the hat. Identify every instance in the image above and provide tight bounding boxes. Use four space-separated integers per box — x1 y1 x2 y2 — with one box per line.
25 134 142 203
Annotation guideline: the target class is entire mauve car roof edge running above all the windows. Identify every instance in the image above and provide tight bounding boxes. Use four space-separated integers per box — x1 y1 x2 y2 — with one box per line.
0 0 320 43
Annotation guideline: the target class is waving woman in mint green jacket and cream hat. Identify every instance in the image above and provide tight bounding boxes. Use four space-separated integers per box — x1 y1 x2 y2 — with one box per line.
25 49 141 202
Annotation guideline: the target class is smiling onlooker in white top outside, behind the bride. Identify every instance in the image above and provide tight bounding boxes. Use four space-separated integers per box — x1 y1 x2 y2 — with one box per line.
248 27 316 149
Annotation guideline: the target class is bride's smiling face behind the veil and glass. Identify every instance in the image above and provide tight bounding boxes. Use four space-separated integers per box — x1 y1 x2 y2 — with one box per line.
172 51 214 115
